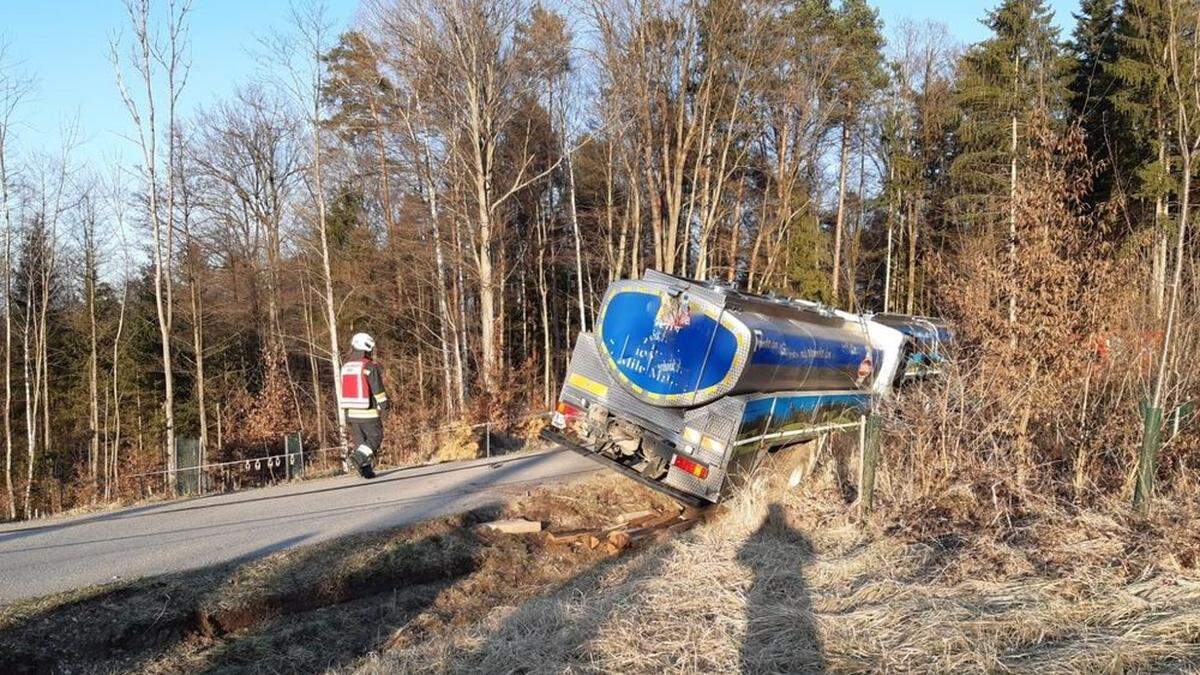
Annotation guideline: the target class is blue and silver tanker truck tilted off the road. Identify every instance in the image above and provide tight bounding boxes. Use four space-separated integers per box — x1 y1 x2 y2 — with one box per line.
544 270 952 504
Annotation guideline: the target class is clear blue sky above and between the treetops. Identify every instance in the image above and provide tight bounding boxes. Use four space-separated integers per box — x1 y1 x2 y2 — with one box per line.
0 0 1079 165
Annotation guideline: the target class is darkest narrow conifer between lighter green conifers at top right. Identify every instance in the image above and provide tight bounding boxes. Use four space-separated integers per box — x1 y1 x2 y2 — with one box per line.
1070 0 1123 204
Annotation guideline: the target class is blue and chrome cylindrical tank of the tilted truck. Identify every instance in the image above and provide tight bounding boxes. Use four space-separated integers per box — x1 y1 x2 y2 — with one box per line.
595 270 904 407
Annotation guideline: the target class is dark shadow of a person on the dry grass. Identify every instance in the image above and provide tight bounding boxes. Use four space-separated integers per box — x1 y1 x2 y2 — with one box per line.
738 504 826 673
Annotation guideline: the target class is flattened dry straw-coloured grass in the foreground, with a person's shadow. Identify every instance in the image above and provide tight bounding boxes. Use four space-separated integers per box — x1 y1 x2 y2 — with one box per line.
358 449 1200 673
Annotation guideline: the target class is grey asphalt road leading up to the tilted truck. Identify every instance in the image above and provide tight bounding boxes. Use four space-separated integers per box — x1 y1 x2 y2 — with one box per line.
0 449 598 604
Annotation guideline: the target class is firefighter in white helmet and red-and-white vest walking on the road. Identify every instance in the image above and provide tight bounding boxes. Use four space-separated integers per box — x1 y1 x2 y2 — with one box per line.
338 333 389 478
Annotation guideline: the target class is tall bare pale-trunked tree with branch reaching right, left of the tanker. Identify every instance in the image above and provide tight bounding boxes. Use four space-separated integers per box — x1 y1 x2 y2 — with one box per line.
377 0 558 392
